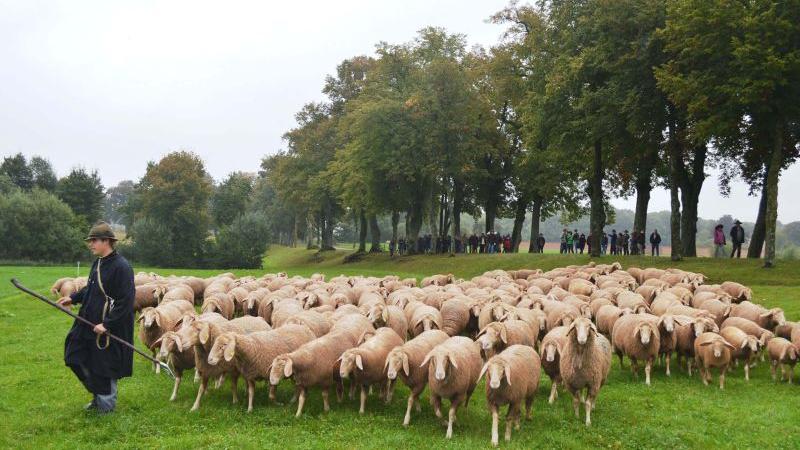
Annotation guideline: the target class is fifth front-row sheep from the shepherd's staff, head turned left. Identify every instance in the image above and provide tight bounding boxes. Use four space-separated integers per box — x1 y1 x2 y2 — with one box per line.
339 327 403 414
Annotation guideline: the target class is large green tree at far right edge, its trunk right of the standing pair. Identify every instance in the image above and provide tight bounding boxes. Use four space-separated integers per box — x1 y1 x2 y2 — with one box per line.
656 0 800 267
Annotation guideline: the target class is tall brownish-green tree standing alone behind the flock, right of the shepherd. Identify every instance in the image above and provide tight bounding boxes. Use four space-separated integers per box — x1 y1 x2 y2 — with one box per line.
133 151 212 267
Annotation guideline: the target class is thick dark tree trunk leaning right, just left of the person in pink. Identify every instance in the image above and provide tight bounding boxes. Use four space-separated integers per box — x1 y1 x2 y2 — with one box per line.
680 144 707 256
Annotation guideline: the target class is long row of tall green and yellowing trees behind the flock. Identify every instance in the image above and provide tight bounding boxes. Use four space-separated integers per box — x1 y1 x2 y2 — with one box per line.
261 0 800 266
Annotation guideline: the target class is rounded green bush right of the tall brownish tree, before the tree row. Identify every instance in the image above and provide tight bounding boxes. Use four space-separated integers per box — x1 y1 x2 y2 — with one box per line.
214 212 269 269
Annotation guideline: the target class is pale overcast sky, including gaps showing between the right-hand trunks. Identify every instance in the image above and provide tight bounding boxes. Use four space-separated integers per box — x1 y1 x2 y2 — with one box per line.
0 0 800 222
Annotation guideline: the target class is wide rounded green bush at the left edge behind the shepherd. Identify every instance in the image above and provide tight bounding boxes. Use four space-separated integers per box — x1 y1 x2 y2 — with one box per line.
0 189 87 262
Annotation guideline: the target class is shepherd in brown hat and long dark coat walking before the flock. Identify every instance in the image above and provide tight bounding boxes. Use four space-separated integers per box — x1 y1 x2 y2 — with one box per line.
58 222 136 413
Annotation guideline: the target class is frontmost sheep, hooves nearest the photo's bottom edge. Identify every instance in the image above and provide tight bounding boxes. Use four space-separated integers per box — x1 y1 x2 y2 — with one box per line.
478 345 541 446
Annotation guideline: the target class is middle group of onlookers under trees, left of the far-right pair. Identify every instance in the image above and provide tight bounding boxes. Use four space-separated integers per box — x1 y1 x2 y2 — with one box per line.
556 228 661 256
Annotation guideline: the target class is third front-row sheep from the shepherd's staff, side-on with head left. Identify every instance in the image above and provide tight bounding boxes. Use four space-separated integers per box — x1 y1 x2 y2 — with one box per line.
208 324 316 412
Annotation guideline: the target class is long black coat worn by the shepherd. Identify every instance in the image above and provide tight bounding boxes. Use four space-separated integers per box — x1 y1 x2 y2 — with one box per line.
64 252 136 379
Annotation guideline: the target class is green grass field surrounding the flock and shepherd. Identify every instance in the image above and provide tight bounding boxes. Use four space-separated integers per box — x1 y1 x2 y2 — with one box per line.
0 247 800 448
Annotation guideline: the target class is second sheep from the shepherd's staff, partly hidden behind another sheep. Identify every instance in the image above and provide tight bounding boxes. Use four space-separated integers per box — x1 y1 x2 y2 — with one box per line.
184 316 270 411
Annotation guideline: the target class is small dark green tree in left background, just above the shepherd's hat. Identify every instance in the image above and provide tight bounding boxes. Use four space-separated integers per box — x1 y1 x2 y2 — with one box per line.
56 167 105 224
